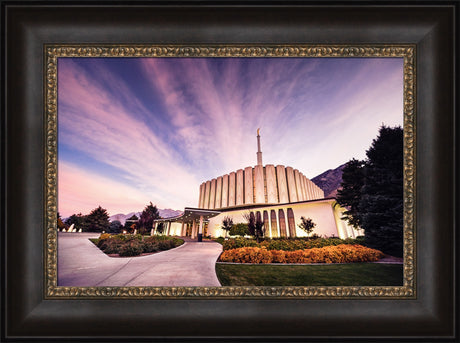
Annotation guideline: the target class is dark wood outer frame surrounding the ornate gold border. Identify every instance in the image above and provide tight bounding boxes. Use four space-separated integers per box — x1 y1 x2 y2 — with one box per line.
2 2 458 341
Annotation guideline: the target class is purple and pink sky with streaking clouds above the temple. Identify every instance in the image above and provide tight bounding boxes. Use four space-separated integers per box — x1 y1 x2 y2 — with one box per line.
58 57 403 217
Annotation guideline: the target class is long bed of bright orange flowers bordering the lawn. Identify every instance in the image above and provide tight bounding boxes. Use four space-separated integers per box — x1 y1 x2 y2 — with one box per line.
219 244 384 263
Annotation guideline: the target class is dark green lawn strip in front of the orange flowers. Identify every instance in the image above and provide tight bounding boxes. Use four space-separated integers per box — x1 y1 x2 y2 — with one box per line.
216 263 403 286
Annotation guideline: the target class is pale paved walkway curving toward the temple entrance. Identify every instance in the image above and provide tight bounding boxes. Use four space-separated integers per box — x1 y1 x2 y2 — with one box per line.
58 232 222 287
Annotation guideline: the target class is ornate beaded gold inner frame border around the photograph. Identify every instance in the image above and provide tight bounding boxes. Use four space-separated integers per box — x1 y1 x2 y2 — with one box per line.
44 44 416 299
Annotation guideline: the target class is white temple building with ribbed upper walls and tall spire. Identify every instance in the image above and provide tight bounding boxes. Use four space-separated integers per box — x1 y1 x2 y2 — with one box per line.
154 130 363 240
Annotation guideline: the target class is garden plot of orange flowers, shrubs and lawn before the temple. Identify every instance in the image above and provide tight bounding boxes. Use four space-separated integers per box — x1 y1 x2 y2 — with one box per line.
216 237 403 286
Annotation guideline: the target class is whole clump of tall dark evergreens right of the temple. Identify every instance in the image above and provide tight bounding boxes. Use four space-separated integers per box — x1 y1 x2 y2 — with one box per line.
337 126 404 256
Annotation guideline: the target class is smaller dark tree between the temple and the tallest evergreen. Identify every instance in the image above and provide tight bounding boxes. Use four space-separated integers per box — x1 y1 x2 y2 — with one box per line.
337 159 365 228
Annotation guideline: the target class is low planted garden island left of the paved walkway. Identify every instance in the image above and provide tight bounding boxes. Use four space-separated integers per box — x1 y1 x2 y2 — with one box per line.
91 233 184 257
